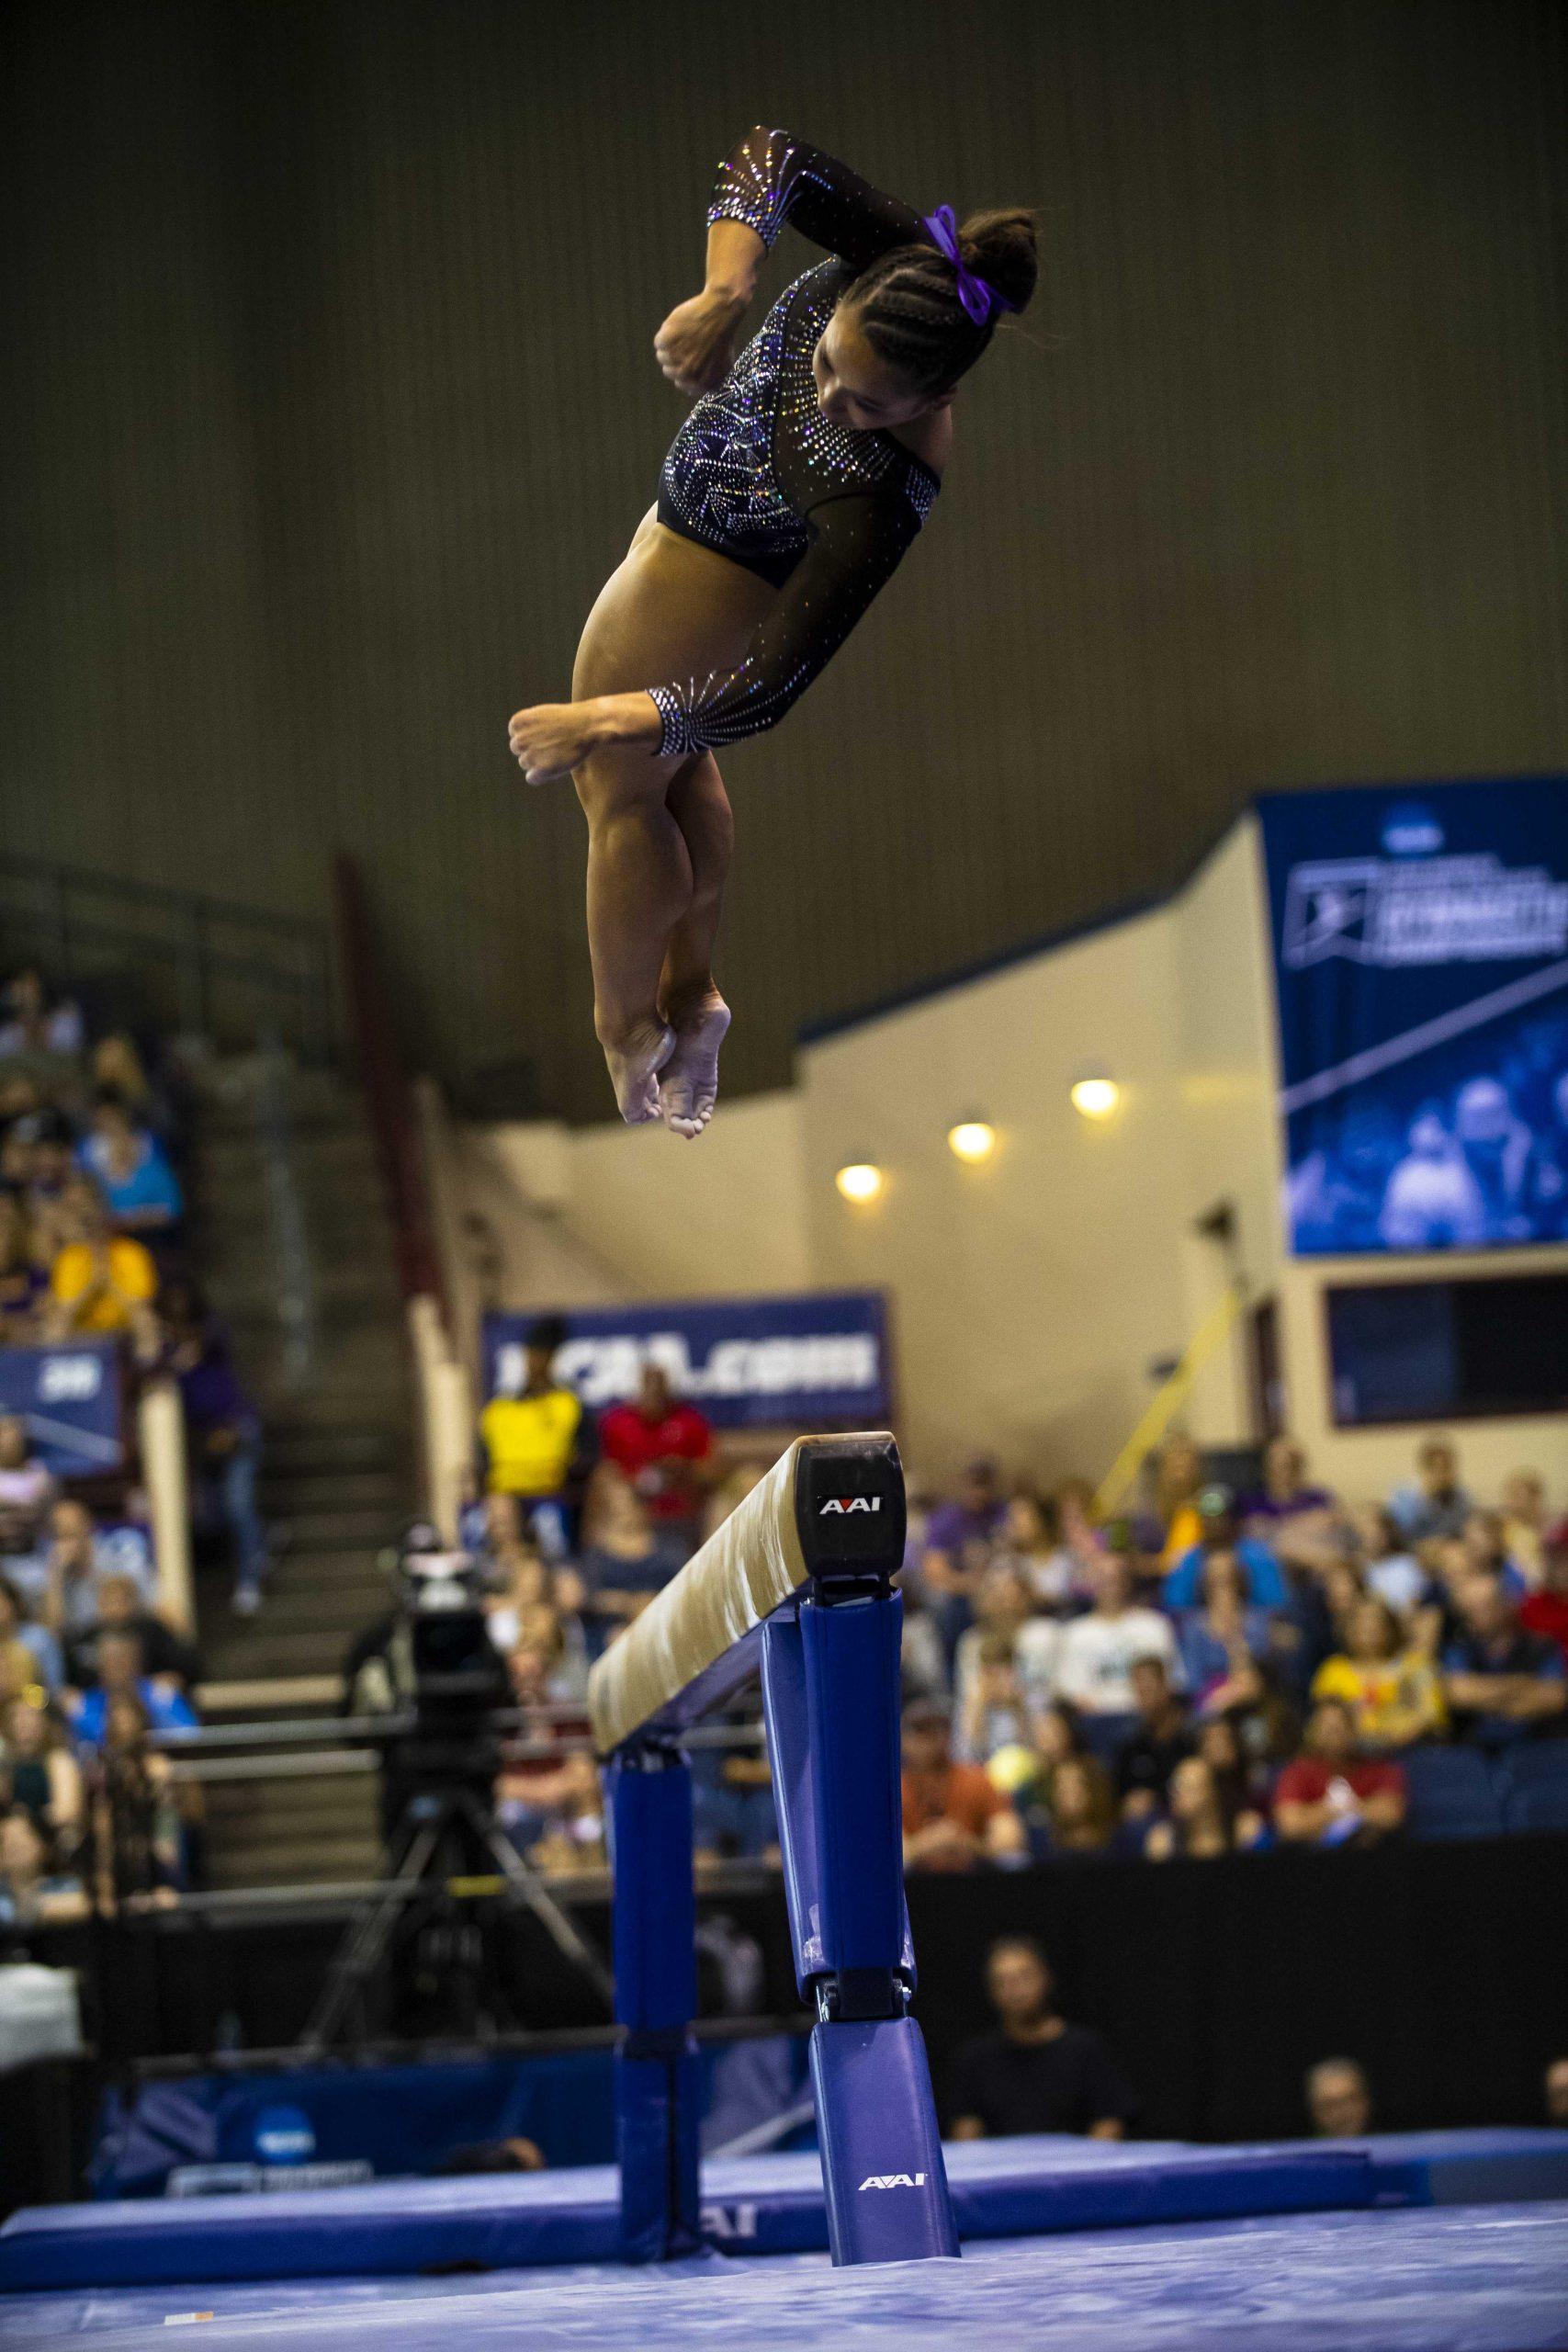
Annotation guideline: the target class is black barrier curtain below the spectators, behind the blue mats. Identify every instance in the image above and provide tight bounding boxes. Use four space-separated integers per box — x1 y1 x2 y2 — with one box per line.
33 1835 1568 2141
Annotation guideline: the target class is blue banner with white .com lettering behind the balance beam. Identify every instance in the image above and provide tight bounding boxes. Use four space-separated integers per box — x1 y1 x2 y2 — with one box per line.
484 1291 894 1430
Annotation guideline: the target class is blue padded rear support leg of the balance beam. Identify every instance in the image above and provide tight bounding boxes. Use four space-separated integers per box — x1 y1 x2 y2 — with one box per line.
609 1740 701 2263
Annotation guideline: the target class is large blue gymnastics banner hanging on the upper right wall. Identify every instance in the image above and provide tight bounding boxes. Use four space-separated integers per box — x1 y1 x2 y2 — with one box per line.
1260 776 1568 1256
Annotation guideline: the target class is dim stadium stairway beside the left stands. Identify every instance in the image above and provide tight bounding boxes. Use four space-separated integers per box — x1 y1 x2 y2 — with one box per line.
193 1054 416 1889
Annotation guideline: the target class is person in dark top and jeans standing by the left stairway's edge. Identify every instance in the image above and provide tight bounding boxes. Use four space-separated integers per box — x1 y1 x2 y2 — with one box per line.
163 1277 268 1616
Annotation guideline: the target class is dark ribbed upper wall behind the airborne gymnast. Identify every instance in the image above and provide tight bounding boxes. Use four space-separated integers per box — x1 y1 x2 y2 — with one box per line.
0 0 1568 1117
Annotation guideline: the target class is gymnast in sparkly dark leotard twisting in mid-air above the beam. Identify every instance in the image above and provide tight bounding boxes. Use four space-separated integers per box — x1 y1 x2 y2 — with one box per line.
510 127 1034 1136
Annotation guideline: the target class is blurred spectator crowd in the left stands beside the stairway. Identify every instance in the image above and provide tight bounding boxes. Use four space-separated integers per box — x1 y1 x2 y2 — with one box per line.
0 969 265 1931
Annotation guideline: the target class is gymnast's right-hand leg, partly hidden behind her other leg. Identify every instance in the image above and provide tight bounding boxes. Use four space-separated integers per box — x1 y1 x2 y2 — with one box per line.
659 751 736 1136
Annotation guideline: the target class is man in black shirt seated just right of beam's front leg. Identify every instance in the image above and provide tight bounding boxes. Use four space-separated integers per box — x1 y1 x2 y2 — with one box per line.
947 1936 1138 2141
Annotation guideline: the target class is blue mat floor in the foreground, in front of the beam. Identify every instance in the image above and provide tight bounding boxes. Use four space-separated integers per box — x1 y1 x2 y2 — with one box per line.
0 2204 1568 2352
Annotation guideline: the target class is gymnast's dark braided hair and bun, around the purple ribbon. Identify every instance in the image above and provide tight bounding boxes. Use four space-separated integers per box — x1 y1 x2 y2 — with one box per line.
840 207 1039 400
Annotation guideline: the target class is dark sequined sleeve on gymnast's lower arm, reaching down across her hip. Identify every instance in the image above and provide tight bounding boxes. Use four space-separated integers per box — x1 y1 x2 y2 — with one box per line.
647 492 919 760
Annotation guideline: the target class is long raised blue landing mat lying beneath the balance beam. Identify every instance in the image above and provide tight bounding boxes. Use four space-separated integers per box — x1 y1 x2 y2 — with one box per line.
0 2131 1568 2293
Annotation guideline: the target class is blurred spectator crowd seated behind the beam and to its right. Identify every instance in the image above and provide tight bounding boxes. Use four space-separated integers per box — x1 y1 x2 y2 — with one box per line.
394 1322 1568 1870
